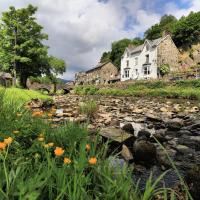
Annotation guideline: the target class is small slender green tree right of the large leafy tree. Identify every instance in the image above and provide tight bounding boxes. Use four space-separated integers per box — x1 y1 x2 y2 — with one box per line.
48 56 66 93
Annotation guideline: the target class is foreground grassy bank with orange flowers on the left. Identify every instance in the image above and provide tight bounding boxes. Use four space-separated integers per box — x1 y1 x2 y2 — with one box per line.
0 89 191 200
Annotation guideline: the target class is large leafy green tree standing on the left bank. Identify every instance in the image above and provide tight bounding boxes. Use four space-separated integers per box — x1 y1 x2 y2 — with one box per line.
0 5 49 88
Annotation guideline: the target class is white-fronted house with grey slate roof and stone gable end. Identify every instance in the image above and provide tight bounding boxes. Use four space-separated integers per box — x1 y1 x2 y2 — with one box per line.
121 35 179 81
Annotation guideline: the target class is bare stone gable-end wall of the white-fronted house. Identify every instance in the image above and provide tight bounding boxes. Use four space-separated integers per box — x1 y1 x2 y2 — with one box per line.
157 36 179 71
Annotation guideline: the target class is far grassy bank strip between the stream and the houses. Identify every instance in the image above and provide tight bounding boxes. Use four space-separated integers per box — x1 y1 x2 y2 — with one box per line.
75 80 200 100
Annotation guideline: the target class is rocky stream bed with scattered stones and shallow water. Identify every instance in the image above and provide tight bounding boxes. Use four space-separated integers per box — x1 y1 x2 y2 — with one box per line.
28 94 200 200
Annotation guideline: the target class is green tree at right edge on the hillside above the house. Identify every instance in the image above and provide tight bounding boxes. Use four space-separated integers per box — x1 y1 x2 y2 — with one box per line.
173 12 200 48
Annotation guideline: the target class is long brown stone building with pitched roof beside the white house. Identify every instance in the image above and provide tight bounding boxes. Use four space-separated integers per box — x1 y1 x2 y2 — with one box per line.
75 62 120 85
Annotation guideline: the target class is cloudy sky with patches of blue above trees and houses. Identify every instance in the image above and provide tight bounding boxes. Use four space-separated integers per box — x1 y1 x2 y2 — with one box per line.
0 0 200 80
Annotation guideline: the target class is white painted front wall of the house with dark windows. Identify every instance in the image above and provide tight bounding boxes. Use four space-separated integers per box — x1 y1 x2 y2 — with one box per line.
121 42 157 81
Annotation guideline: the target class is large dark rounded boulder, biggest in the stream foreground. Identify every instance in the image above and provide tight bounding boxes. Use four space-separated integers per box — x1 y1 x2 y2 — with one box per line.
133 140 156 166
